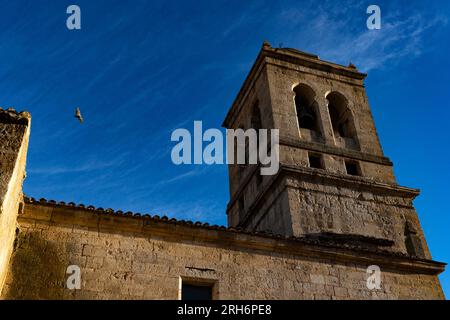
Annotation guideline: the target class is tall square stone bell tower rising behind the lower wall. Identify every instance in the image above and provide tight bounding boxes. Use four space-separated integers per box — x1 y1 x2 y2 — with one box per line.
223 42 431 259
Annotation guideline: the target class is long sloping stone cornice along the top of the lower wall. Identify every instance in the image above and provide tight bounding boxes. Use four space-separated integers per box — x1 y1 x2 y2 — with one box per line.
19 198 446 275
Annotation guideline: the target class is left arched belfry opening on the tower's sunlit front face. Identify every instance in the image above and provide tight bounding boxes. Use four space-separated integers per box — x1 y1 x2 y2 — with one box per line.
294 84 320 135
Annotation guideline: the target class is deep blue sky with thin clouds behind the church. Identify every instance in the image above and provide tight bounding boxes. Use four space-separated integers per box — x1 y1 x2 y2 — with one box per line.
0 0 450 297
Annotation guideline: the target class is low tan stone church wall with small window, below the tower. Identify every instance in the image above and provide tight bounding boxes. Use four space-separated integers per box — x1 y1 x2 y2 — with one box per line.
3 203 444 299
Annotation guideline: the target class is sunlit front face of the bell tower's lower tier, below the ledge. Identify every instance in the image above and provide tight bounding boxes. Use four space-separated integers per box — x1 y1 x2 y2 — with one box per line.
286 178 431 259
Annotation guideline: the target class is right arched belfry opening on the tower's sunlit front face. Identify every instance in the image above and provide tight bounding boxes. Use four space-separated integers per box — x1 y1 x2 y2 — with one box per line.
327 92 358 149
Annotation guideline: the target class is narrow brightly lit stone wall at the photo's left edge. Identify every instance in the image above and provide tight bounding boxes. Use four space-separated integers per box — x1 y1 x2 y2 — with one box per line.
0 108 30 294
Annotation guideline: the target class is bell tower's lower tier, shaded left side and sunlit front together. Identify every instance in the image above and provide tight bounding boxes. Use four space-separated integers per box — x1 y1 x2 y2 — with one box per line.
239 173 431 259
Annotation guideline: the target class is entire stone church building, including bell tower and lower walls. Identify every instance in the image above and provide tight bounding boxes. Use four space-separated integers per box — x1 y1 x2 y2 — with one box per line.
0 43 445 299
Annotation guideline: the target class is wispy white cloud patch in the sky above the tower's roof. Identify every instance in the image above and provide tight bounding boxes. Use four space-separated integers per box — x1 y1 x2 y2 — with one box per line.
278 1 448 72
